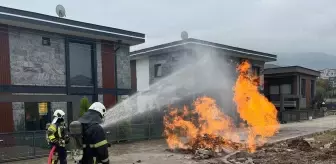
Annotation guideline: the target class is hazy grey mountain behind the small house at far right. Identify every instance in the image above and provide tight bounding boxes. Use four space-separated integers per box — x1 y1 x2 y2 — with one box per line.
269 52 336 70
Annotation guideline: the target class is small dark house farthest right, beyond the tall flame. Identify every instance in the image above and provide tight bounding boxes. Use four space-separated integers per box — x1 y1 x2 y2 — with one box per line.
264 66 320 121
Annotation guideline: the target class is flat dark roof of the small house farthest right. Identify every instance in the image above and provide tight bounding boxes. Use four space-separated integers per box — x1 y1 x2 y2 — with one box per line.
264 66 320 77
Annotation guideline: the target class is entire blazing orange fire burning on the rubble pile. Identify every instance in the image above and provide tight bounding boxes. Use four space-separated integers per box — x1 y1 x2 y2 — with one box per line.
164 61 279 152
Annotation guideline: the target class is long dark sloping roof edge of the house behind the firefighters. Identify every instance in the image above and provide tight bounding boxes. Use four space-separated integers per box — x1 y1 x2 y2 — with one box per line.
0 6 145 45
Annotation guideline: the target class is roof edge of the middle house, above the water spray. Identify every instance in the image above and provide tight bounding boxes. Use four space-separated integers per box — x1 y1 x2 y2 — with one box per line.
131 38 277 61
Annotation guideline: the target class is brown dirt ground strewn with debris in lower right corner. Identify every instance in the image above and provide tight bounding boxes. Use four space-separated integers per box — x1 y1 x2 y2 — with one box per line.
229 131 336 164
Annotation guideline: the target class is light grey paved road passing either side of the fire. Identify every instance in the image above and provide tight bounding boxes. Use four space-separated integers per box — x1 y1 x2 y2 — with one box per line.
10 116 336 164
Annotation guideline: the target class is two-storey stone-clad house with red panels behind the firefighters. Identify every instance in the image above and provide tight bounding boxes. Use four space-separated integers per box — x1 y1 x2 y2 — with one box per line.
0 7 145 132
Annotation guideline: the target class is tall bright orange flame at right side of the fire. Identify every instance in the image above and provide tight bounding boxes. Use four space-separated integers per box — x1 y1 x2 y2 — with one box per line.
233 61 279 151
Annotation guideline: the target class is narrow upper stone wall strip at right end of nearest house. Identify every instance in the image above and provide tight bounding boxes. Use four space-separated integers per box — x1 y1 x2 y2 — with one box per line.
117 46 131 89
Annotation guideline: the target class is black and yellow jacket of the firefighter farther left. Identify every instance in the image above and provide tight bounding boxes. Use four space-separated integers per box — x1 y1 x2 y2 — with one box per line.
47 122 66 147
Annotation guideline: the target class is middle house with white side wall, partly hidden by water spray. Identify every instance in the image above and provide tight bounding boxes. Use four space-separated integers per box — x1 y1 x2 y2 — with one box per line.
131 38 276 124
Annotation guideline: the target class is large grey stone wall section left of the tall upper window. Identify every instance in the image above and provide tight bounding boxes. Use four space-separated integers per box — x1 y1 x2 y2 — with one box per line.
9 28 65 86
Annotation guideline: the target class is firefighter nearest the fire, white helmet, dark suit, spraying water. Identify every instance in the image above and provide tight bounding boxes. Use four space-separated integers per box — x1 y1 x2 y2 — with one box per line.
78 102 110 164
